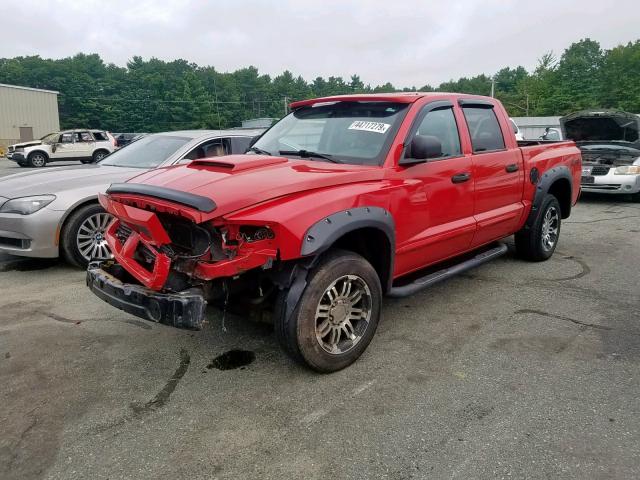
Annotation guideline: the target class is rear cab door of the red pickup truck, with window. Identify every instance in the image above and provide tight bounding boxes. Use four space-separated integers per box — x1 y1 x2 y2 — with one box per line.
460 100 524 247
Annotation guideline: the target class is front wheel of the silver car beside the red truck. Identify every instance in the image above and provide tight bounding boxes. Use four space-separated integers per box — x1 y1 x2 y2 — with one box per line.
60 203 113 268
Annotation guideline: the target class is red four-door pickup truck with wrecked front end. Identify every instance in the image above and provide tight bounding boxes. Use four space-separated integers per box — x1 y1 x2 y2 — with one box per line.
87 93 581 372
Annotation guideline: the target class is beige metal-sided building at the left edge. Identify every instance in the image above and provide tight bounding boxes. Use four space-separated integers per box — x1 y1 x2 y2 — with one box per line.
0 83 60 149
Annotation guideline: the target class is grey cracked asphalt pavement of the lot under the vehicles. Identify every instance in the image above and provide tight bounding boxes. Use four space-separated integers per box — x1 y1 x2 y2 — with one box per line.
0 159 640 480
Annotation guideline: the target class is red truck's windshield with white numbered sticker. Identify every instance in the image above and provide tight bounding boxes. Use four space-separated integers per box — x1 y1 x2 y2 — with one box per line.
253 102 408 165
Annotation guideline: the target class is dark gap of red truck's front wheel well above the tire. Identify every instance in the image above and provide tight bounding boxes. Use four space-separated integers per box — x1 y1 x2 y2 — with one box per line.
332 227 392 292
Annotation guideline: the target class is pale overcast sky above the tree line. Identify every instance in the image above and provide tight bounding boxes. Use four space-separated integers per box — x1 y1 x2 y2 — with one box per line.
0 0 640 88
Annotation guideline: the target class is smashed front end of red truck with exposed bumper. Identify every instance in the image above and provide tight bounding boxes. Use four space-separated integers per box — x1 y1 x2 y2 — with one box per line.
87 184 278 329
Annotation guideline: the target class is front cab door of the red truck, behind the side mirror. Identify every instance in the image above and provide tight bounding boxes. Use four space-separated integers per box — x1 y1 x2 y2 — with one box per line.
395 101 476 275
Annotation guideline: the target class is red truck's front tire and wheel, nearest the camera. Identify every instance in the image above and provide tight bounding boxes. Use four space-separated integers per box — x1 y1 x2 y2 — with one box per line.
274 250 382 373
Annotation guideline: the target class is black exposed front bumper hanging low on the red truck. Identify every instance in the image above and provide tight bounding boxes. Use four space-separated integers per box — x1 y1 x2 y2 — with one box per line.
87 261 207 330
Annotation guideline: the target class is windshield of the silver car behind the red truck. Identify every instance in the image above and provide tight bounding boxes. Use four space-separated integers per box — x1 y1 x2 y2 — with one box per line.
100 135 191 168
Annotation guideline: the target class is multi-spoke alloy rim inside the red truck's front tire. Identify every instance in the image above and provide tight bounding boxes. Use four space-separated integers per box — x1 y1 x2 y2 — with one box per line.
315 275 373 355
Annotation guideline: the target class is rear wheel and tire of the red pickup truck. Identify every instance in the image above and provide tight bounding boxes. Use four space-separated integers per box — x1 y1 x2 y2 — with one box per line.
515 193 562 262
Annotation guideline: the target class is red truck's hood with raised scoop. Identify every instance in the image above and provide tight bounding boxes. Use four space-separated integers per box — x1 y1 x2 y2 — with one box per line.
127 155 384 220
